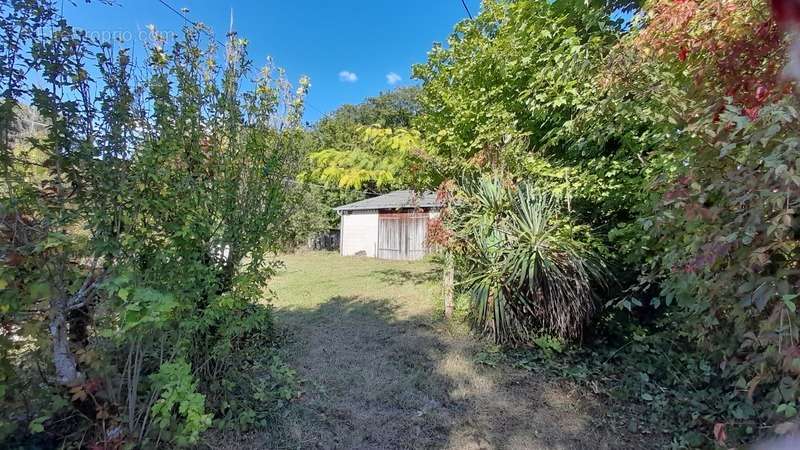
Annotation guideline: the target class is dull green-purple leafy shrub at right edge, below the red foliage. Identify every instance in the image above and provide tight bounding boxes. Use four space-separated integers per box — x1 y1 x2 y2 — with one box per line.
651 98 800 440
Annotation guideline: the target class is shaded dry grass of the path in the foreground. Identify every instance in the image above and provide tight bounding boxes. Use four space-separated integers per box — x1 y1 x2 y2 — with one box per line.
214 297 640 449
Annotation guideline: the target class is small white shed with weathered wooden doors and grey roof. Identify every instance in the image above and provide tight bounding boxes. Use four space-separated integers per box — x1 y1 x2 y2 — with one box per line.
336 190 442 260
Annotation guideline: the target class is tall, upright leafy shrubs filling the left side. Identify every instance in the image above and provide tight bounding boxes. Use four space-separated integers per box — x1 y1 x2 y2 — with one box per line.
0 1 308 448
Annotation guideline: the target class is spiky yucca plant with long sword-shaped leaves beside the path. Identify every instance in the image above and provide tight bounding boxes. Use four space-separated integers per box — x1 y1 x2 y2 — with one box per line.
448 178 607 344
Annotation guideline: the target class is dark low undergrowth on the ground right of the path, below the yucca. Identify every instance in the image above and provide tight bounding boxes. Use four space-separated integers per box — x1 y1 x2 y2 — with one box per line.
475 330 760 449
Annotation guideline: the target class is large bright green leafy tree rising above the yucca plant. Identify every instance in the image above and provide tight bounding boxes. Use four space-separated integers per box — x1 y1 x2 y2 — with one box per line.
414 1 636 312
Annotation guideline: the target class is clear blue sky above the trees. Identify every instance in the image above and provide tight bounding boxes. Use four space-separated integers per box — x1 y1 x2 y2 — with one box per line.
63 0 480 122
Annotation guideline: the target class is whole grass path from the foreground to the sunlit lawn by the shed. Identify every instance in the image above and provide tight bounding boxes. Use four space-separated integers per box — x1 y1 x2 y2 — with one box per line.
223 252 647 449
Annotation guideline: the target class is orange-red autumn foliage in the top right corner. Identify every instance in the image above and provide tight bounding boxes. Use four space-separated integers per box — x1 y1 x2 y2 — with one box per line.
637 0 785 111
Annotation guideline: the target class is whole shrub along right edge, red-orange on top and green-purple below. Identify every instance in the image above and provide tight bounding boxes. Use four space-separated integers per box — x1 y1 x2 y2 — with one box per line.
633 0 800 445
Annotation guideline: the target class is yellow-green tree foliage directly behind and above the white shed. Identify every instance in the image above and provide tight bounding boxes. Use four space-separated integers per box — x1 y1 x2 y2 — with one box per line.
292 87 424 239
